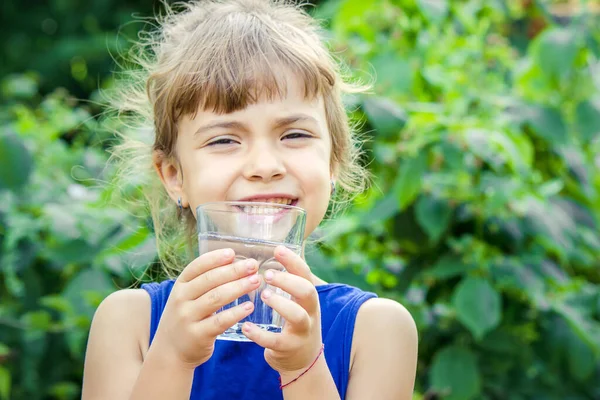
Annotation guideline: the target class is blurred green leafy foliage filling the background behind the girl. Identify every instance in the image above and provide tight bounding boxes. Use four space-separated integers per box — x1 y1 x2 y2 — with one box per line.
0 0 600 400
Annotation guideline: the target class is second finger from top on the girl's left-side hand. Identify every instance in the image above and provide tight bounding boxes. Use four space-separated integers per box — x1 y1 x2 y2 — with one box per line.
186 259 258 299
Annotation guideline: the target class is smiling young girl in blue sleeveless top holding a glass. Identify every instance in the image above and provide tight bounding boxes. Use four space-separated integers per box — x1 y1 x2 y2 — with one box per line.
83 0 417 400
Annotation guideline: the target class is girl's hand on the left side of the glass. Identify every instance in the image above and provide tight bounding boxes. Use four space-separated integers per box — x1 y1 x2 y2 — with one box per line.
152 249 260 368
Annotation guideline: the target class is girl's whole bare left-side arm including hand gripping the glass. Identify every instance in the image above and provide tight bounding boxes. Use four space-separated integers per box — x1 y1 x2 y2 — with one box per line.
82 249 260 400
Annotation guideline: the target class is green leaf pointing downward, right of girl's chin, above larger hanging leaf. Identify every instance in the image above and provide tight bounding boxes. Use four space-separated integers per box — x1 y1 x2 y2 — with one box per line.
415 196 452 243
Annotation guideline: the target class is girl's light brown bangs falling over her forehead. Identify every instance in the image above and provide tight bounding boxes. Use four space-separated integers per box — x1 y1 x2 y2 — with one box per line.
162 15 336 121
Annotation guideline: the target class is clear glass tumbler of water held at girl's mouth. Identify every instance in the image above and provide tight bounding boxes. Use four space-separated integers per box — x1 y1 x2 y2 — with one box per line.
196 199 306 341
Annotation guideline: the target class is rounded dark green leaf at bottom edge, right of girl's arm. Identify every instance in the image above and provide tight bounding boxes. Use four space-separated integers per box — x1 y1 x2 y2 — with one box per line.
430 345 481 400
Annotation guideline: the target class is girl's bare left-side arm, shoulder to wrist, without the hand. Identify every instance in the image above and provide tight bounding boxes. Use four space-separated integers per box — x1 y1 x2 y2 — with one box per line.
82 289 193 400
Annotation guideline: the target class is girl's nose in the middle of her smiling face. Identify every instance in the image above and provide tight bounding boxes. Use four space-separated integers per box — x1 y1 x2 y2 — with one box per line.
243 140 286 182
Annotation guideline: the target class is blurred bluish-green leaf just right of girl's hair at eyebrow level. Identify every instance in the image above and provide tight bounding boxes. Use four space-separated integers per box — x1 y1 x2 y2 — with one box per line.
363 97 407 138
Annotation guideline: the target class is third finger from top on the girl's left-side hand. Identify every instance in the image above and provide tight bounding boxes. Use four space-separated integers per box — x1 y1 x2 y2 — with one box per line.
194 274 260 319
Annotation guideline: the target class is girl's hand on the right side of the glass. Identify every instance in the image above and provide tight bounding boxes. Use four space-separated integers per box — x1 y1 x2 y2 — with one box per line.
242 246 322 374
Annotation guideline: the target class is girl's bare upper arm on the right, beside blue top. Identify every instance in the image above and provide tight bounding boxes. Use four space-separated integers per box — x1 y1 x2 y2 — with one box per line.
347 299 418 400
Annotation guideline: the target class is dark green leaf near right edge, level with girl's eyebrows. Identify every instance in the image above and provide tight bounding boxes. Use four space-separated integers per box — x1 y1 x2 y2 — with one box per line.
523 105 568 145
